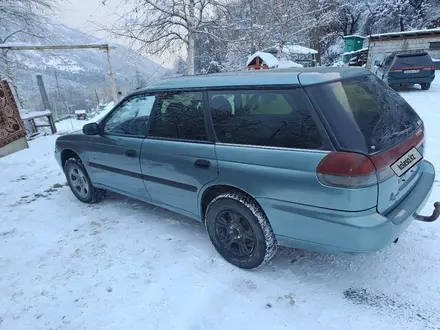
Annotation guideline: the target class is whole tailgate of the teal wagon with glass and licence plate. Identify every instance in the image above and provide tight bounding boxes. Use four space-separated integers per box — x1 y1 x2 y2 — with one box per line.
308 75 424 218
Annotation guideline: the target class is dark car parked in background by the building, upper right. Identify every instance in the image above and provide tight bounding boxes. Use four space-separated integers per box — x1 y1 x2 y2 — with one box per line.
375 52 435 90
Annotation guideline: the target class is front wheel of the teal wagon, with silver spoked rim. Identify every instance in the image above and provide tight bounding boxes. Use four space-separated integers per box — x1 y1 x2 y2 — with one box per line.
64 158 105 204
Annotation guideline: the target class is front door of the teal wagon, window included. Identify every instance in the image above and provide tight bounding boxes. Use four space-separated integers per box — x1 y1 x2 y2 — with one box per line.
88 95 155 199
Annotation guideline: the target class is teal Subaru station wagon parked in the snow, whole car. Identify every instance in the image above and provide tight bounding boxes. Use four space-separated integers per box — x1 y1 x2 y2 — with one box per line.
55 68 440 269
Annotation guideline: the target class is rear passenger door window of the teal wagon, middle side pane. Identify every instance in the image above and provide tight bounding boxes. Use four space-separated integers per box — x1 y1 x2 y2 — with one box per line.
148 92 207 141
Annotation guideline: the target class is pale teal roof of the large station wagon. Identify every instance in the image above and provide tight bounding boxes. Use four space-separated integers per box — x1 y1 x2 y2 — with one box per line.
135 67 371 94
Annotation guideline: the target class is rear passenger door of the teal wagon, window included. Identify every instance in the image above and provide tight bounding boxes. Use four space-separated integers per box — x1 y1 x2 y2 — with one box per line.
141 92 218 217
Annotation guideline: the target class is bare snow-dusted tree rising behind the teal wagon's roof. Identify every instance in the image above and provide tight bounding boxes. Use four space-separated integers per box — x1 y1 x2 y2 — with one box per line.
101 0 224 75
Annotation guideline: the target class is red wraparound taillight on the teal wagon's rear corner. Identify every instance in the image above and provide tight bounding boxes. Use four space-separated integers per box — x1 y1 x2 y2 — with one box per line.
316 152 377 188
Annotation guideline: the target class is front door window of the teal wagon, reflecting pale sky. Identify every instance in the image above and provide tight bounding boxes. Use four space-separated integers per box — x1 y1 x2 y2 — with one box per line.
104 95 156 136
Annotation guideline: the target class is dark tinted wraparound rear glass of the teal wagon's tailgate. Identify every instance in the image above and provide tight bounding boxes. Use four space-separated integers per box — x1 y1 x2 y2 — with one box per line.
311 75 422 154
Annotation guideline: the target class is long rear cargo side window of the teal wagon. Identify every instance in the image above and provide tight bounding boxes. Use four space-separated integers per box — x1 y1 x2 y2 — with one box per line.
208 90 323 149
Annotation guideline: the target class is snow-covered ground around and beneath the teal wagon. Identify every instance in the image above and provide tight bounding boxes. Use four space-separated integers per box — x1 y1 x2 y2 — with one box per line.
0 77 440 330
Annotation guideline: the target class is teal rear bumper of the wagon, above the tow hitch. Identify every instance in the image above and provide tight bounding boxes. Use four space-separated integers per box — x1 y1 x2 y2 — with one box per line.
257 161 435 253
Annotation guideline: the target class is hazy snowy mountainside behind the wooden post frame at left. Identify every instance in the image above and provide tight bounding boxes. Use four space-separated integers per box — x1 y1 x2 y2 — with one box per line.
0 24 167 113
